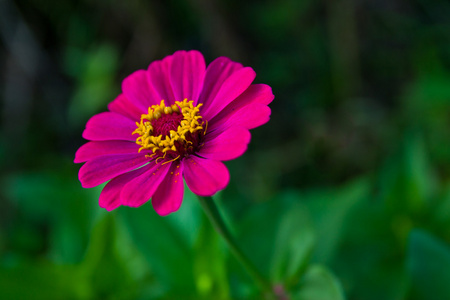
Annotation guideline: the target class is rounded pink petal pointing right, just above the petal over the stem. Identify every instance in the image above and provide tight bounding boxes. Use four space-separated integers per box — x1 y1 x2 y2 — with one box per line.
198 126 251 160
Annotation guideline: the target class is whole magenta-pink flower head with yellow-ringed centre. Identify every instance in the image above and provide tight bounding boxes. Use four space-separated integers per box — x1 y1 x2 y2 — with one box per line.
75 51 274 215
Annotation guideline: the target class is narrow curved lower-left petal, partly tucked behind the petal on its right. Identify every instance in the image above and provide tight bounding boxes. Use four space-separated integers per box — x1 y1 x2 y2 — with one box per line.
98 166 149 211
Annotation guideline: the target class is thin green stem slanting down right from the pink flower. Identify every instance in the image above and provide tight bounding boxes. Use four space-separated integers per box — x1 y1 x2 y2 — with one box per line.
198 196 272 293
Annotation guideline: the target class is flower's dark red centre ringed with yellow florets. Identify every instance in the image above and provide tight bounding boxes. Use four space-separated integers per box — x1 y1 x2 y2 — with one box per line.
132 99 206 164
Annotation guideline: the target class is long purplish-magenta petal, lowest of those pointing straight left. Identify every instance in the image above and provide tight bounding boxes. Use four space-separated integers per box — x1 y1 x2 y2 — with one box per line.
78 153 148 188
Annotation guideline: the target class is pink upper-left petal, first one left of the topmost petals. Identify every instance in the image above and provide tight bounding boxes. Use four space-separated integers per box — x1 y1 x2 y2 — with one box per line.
122 70 161 111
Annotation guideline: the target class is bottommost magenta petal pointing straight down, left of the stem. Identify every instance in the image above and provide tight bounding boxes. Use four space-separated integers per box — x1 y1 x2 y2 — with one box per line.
152 163 184 216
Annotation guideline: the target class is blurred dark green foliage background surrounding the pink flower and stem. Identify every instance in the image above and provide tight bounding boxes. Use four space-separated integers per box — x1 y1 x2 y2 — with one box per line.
0 0 450 300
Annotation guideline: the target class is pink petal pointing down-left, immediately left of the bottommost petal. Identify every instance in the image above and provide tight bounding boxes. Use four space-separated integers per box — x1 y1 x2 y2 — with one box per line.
120 162 171 207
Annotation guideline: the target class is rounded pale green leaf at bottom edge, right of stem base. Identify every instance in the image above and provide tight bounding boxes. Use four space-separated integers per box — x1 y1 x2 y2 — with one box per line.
292 265 345 300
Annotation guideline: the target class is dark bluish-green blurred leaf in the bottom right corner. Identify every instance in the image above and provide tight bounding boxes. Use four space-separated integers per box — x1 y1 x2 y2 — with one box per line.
408 230 450 299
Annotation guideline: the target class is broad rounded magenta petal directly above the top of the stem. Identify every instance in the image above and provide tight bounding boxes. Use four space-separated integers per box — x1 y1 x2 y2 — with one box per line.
183 156 230 196
